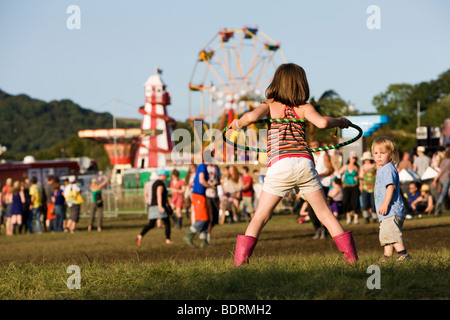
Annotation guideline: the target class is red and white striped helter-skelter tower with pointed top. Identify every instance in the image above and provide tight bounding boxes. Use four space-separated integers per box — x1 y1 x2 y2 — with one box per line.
135 68 175 168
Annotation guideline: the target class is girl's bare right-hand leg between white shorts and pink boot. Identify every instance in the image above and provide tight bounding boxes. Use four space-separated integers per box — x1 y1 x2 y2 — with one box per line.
305 189 344 237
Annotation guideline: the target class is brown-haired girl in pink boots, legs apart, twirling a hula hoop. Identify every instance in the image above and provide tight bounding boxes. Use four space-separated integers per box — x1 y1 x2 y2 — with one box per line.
229 63 358 266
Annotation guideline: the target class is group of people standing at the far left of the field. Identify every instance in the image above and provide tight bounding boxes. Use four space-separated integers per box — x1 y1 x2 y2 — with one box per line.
0 175 108 236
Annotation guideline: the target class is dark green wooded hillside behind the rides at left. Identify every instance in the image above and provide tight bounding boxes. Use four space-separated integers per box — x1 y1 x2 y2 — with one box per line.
0 90 140 165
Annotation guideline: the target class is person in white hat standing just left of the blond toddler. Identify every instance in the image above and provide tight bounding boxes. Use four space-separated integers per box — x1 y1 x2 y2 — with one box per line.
359 151 377 223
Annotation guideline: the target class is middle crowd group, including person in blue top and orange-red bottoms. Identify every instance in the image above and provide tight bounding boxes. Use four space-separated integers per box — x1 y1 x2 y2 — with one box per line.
136 163 262 247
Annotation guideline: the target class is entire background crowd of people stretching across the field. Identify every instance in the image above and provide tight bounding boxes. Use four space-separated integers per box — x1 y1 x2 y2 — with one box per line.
0 141 450 246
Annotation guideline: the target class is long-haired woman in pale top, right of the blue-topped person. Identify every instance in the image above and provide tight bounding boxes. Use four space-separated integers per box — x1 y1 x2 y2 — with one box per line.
221 165 243 224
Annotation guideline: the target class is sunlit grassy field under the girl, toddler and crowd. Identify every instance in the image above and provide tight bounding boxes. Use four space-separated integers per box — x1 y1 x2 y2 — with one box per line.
0 211 450 300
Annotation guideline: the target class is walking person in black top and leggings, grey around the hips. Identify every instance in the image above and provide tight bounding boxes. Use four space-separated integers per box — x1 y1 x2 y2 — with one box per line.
136 169 172 246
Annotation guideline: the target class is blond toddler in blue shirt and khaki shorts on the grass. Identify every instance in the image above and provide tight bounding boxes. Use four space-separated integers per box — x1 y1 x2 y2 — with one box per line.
372 137 411 262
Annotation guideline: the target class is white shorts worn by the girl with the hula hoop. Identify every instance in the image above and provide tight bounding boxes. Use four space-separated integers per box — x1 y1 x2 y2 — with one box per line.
263 157 322 197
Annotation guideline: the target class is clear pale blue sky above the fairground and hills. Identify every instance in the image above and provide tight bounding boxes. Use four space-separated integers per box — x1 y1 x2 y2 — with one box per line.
0 0 450 120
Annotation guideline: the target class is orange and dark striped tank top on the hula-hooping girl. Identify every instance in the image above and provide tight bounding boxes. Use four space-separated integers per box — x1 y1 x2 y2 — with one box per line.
267 106 314 167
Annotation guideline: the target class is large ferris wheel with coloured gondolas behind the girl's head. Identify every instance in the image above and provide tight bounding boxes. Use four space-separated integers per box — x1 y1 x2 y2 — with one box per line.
189 27 286 130
